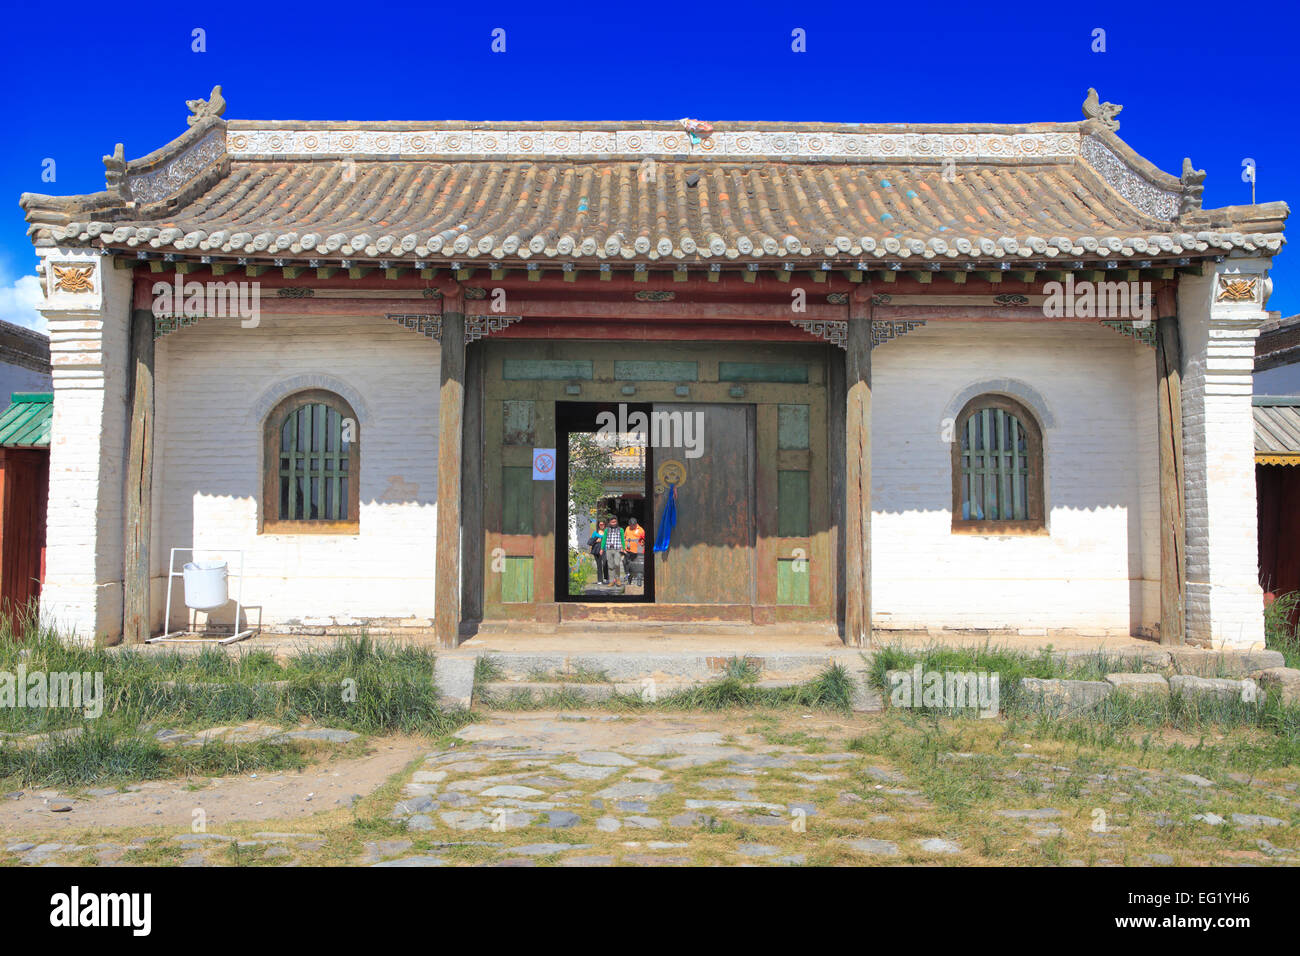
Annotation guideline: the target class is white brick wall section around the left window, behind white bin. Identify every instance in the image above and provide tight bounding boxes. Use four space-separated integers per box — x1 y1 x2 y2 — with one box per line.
152 315 439 627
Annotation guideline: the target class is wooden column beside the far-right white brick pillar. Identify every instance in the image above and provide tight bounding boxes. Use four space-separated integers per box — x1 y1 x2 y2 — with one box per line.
1156 287 1187 644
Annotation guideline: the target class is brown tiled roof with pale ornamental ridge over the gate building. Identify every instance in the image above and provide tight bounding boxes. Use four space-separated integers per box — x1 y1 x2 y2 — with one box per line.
22 100 1287 267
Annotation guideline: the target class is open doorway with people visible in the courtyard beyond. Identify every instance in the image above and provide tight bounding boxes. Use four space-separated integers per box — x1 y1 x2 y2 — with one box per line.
555 402 655 604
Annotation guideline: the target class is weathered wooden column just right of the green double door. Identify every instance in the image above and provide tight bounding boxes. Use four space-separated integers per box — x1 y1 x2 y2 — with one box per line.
844 284 871 648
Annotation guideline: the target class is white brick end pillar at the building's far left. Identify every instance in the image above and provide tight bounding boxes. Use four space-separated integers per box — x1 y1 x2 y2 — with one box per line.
40 250 131 643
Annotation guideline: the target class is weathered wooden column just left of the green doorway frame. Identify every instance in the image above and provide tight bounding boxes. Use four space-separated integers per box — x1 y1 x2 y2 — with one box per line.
433 295 465 648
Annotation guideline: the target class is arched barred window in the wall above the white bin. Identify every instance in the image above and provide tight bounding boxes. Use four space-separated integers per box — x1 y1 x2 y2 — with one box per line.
261 389 361 533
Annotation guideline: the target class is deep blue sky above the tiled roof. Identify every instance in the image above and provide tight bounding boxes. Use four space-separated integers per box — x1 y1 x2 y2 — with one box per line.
0 0 1300 326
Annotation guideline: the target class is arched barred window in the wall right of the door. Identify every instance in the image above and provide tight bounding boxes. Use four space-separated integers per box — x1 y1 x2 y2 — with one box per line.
953 395 1047 535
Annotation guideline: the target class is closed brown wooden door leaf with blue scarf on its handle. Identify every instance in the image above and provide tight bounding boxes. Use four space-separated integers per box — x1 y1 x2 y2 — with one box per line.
651 403 755 604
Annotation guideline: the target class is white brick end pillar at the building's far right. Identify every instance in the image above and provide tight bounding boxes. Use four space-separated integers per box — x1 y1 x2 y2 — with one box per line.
1178 260 1268 646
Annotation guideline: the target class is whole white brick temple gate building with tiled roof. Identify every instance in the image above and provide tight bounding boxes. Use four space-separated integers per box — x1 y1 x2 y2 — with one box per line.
21 87 1288 648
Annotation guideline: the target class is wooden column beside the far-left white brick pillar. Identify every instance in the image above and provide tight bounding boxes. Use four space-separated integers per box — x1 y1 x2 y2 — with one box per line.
122 308 154 644
